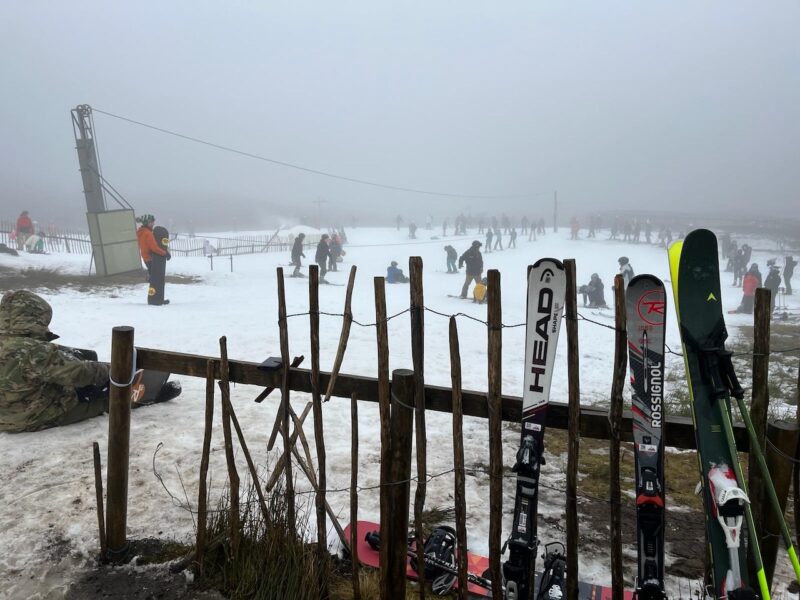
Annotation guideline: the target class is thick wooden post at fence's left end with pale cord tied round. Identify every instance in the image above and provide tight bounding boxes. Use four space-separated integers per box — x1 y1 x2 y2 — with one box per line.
106 326 135 560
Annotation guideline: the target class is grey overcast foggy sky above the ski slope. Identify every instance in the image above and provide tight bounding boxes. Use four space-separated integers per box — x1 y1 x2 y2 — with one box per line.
0 0 800 226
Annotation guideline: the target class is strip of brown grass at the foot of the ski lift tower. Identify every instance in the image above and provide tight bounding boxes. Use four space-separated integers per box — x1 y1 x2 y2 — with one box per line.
0 266 202 292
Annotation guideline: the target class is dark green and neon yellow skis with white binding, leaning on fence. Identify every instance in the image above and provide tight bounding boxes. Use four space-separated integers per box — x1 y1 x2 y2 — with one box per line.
669 229 770 600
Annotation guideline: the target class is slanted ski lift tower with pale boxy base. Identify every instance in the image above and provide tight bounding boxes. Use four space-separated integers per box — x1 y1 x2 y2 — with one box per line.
71 104 142 277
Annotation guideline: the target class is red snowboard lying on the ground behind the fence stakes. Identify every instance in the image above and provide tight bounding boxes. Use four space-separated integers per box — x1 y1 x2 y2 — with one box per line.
344 521 633 600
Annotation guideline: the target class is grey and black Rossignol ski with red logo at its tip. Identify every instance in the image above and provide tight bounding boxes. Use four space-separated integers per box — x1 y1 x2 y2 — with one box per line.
625 275 666 600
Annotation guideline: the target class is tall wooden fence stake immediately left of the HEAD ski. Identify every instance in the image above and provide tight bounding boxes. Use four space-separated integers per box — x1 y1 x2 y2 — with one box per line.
486 269 503 600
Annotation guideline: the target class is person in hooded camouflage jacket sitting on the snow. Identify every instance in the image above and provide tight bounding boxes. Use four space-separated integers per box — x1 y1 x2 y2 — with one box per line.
0 290 109 432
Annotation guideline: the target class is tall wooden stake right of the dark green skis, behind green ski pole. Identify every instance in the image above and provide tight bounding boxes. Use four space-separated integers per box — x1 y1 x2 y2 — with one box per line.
747 288 777 583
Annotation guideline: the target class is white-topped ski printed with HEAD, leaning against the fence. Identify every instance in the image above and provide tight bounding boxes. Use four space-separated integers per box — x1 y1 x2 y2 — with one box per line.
503 258 566 600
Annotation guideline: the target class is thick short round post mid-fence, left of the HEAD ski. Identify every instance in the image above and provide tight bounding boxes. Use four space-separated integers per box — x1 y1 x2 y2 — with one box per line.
380 369 414 600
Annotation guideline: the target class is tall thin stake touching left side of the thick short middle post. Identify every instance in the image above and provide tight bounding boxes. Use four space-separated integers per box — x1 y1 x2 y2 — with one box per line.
373 277 392 590
